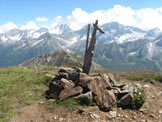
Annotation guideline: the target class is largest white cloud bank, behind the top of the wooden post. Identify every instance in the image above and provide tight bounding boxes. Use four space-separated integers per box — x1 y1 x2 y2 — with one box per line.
67 5 162 30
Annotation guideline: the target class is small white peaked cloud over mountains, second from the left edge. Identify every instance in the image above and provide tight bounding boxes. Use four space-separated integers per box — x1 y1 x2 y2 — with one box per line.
20 21 39 30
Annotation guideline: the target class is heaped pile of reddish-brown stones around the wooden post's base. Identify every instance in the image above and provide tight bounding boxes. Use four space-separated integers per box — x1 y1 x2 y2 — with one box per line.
48 67 142 111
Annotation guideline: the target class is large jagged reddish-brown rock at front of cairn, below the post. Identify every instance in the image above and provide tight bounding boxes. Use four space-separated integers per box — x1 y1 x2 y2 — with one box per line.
88 77 116 111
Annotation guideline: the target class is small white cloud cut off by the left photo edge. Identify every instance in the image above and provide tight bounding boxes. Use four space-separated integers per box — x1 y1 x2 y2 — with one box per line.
0 22 17 33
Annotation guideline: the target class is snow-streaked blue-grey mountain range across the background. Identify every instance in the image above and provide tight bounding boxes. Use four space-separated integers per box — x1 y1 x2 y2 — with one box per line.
0 22 162 72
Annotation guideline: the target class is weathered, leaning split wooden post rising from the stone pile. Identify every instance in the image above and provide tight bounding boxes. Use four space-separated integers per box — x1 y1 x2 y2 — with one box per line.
83 20 104 74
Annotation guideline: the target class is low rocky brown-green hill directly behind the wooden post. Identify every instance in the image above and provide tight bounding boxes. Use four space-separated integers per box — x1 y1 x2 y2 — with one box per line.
21 49 103 70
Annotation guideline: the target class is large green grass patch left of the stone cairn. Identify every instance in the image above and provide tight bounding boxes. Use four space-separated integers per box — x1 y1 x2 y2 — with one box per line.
0 66 57 122
